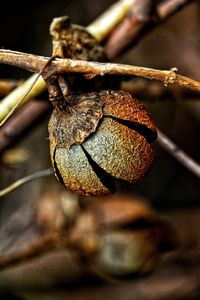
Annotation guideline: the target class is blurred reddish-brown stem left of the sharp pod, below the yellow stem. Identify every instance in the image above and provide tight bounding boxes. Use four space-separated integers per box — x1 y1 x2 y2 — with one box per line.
0 100 51 152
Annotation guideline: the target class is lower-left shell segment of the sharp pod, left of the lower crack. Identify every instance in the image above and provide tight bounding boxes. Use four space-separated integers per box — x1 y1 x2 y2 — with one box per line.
52 145 109 195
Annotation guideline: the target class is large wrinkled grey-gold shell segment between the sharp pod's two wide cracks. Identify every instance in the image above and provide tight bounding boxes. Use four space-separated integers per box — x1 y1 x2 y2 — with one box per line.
83 118 154 182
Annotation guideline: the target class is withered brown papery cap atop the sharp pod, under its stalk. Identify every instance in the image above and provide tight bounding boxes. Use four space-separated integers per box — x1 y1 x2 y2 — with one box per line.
49 93 103 149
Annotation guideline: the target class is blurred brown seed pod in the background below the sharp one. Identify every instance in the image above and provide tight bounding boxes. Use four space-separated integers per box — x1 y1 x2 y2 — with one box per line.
69 195 176 278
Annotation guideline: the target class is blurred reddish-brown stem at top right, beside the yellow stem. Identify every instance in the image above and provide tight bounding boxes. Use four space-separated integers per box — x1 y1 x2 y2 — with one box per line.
105 0 193 60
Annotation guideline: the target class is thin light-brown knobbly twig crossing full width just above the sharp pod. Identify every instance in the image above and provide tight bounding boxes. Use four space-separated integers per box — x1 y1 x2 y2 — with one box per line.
0 50 200 92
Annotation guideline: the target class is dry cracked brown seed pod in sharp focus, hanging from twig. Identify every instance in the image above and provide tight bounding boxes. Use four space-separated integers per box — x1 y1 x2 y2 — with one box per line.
49 90 157 196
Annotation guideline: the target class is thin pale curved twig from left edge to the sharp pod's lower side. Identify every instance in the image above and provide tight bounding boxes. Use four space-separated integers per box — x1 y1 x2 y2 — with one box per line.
0 168 54 198
